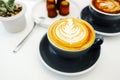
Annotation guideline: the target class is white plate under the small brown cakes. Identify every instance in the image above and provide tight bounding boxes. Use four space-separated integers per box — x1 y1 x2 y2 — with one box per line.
32 0 80 25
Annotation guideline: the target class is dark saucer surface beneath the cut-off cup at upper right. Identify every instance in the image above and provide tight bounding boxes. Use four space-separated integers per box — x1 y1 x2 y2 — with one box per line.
80 6 120 34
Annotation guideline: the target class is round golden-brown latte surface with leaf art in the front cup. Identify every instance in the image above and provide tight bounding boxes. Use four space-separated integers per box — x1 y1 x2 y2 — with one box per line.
47 18 95 51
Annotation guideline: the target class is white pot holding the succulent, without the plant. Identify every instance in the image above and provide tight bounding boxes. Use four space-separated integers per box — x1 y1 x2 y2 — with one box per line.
0 2 26 33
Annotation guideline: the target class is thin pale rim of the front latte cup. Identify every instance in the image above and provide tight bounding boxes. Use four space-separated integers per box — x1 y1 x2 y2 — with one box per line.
47 19 96 53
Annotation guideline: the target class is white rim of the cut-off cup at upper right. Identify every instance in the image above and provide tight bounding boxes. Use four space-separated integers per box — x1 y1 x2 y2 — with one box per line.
89 0 120 16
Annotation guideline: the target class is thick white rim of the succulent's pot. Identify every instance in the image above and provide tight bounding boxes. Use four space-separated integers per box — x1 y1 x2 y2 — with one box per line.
0 1 26 21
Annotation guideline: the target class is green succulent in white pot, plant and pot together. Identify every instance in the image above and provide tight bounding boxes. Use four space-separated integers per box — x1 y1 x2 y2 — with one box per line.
0 0 26 32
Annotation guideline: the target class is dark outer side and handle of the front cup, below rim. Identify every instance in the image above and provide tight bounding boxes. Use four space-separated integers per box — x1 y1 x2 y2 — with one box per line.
50 36 103 59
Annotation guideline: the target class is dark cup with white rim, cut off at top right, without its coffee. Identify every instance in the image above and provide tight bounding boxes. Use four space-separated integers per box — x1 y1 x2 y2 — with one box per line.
89 0 120 27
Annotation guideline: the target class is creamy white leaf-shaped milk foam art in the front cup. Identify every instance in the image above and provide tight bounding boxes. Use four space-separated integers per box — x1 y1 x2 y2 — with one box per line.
56 19 87 44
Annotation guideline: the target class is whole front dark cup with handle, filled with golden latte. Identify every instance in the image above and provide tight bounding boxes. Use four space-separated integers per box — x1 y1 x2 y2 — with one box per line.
47 18 103 58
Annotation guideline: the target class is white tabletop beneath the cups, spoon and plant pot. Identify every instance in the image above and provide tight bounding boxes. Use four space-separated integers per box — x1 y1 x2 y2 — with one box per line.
0 0 120 80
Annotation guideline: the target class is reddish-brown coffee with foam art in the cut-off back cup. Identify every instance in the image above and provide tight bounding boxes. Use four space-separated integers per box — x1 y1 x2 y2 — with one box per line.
92 0 120 14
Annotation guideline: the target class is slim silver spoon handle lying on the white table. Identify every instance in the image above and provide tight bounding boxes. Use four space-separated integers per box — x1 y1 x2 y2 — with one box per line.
13 22 36 53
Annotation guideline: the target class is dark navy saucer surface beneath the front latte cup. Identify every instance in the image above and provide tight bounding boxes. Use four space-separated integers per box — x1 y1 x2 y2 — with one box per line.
39 35 100 73
